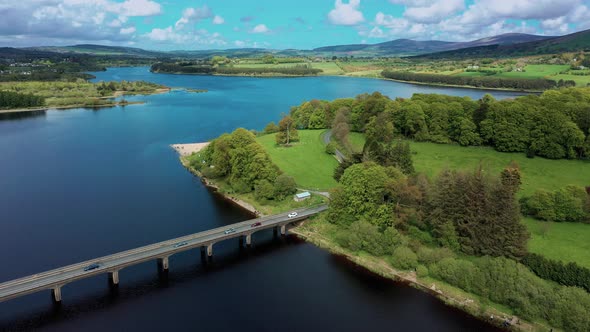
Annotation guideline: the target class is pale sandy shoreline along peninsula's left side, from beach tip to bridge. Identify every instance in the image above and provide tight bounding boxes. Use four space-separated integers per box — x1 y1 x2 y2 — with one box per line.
170 142 264 218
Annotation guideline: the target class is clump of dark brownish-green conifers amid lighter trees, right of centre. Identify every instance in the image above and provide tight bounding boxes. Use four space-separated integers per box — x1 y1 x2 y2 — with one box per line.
428 167 528 257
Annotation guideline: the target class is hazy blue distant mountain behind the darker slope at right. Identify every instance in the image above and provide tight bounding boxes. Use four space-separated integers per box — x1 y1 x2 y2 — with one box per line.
312 33 552 56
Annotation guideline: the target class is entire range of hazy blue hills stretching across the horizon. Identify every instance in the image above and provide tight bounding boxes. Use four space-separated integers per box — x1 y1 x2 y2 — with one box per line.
0 30 590 59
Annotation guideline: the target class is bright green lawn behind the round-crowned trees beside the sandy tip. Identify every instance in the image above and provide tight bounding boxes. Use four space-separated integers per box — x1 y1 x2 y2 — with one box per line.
258 130 338 190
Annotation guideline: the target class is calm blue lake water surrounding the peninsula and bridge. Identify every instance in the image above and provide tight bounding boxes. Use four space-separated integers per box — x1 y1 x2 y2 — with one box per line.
0 68 514 331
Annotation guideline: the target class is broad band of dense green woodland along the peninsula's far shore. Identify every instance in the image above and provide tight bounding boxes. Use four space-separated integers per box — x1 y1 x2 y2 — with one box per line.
290 88 590 159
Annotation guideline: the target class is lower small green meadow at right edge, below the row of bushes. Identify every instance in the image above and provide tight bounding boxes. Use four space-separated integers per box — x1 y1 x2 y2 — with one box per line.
524 218 590 268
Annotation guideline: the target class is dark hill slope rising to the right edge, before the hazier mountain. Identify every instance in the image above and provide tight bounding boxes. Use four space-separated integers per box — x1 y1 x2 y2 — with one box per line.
412 30 590 59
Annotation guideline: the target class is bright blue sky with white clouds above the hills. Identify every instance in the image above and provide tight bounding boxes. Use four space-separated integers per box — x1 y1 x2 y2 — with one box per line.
0 0 590 50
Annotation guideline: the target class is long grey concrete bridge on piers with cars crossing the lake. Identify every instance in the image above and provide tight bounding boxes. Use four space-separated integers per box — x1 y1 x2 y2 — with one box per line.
0 205 328 302
